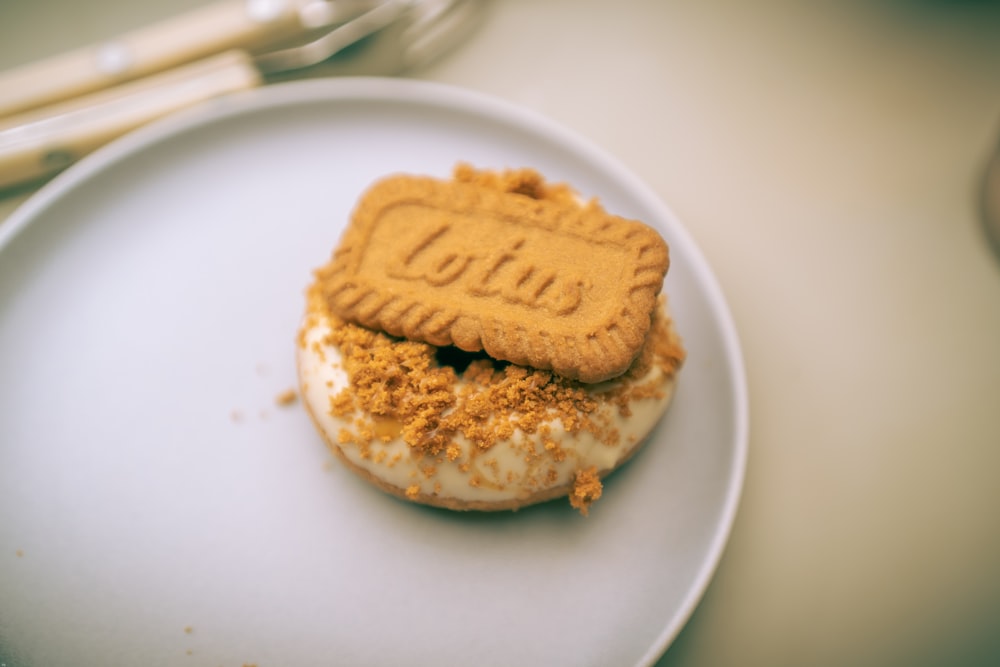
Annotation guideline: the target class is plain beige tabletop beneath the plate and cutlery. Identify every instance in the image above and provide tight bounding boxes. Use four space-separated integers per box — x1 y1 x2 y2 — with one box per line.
0 0 1000 666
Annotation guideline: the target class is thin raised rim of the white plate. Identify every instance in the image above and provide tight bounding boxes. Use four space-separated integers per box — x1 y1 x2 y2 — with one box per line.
0 77 749 666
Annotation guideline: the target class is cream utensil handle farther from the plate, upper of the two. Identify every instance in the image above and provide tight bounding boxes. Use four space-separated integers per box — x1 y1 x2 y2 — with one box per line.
0 0 304 118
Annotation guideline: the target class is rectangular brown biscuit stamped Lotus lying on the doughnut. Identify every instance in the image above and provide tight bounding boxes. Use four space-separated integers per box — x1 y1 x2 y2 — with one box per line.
317 166 669 383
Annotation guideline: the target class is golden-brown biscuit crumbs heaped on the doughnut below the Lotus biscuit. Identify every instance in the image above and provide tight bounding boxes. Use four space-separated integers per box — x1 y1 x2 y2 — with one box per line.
309 276 684 461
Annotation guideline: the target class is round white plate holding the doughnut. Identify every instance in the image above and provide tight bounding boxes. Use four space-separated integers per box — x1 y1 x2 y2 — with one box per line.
0 79 747 667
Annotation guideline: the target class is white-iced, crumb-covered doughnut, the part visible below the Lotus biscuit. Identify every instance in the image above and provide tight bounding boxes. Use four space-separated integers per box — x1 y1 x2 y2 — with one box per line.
298 290 684 514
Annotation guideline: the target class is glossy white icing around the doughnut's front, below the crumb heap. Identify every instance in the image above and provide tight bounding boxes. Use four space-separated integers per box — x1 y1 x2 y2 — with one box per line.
298 314 674 506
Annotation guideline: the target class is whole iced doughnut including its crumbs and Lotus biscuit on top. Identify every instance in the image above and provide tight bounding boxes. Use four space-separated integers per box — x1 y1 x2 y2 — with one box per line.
298 165 684 514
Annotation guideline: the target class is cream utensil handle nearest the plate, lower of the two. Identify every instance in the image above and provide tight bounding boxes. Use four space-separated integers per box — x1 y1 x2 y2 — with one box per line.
0 51 261 188
